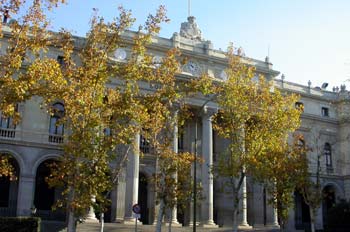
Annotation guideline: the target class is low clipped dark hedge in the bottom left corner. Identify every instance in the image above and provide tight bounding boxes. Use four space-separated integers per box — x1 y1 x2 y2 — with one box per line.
0 217 40 232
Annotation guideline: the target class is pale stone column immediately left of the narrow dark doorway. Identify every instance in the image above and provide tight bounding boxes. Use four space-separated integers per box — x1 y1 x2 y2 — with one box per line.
124 134 140 224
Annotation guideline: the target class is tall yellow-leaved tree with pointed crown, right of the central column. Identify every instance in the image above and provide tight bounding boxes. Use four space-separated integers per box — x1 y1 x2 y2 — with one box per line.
214 47 300 231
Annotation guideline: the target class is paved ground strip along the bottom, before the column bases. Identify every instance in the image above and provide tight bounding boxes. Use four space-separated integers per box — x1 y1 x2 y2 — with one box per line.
41 222 278 232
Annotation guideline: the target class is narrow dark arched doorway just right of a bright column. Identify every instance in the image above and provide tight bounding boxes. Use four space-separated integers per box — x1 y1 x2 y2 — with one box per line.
138 173 150 225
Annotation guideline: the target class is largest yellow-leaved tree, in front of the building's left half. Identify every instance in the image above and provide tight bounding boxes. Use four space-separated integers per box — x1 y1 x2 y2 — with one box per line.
23 7 175 231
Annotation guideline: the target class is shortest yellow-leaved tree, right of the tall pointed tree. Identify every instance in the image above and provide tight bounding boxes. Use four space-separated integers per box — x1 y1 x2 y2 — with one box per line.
254 134 308 231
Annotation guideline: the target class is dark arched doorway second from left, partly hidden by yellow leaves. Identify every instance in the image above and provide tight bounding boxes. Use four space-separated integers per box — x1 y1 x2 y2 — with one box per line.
34 159 65 221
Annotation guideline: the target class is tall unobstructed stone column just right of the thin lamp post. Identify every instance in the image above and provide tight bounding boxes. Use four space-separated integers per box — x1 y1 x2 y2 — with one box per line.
201 108 217 227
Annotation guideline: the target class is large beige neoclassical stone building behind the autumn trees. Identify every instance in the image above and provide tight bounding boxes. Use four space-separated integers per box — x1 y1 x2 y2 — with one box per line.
0 17 350 231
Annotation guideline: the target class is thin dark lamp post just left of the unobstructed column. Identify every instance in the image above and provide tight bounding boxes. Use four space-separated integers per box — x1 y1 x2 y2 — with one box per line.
193 93 218 232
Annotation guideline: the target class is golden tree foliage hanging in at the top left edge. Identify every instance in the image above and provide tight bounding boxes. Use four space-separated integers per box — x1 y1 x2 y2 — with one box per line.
0 0 65 176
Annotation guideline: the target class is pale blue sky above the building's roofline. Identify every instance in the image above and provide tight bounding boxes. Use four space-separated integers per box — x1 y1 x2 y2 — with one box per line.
43 0 350 90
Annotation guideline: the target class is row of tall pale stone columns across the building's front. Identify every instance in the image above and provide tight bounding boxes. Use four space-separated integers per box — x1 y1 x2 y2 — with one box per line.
100 106 278 228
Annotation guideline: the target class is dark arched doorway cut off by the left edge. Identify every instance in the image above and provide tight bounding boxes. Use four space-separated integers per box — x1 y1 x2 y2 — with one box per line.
0 154 20 217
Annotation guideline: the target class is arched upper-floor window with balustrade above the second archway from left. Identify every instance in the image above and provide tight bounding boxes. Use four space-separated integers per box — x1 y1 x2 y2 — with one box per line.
49 102 64 143
